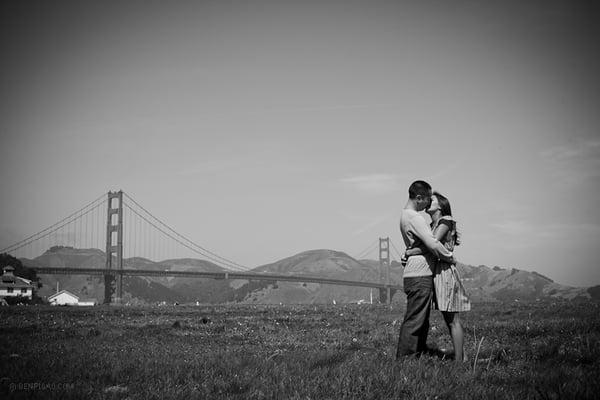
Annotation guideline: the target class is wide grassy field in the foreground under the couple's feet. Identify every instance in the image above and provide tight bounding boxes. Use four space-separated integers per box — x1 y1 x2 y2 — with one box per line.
0 303 600 399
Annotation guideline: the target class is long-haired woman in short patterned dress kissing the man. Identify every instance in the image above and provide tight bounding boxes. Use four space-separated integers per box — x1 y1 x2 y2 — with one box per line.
405 192 471 362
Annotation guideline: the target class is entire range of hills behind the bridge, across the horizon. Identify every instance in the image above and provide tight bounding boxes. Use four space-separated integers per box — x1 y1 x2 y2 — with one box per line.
17 246 600 304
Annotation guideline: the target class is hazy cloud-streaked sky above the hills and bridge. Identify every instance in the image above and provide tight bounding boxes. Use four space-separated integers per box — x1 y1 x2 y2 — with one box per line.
0 0 600 286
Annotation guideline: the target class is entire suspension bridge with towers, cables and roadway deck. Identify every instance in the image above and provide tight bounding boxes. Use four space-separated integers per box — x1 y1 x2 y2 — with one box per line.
0 191 401 304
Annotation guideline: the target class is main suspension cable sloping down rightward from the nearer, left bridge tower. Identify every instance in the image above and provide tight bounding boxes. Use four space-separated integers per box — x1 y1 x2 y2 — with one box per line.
123 193 250 271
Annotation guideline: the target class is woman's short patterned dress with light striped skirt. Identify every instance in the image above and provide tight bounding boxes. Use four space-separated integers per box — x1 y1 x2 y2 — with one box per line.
432 216 471 312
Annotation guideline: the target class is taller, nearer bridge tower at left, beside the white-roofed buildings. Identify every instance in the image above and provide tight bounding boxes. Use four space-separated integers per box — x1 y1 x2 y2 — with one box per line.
104 190 123 304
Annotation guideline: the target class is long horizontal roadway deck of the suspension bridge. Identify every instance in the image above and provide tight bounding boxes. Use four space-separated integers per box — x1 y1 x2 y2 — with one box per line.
33 267 402 290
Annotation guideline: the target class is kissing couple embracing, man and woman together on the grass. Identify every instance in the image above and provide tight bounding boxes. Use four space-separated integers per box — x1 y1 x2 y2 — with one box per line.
396 181 471 362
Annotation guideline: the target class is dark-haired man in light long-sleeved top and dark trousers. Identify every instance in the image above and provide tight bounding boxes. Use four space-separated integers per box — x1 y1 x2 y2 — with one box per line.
396 181 454 358
